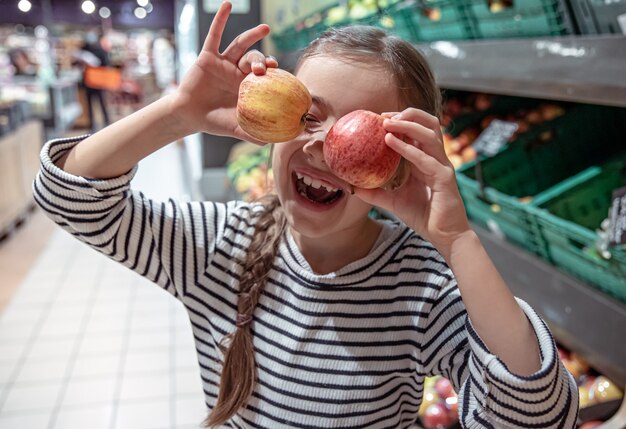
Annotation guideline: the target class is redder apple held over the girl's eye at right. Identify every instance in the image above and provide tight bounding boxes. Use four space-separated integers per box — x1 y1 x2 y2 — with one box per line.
324 110 400 189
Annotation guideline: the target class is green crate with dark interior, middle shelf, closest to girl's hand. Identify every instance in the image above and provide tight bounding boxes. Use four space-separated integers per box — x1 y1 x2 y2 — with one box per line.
457 105 624 258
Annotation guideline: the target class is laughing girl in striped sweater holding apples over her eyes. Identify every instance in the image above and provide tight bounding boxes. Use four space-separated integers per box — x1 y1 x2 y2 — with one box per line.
34 3 578 428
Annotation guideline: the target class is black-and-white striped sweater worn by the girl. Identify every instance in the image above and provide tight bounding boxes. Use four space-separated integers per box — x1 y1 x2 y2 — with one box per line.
34 138 578 429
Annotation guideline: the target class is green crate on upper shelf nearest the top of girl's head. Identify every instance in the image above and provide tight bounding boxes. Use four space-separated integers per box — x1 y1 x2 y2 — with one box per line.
405 0 475 42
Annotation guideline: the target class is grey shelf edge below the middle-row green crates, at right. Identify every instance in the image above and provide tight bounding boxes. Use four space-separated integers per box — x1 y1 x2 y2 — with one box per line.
472 225 626 386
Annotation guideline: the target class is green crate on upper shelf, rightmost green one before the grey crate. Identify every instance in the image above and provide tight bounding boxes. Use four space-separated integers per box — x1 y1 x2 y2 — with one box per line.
464 0 573 39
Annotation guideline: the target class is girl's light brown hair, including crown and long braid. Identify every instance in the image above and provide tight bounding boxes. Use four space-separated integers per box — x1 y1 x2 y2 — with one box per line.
204 26 441 427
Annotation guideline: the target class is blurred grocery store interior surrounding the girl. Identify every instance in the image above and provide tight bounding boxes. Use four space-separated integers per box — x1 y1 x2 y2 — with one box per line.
0 0 626 429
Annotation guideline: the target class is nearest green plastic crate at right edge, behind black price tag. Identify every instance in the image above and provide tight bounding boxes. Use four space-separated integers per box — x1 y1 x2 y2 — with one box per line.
530 156 626 302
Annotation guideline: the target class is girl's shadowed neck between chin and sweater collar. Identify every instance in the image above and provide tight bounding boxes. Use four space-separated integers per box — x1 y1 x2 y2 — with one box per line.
290 218 382 274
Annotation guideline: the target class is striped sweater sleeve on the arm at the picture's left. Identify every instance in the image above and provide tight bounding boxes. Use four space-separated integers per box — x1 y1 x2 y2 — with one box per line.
33 136 234 297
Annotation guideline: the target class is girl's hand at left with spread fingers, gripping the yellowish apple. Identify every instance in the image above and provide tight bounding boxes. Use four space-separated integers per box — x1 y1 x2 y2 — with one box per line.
172 2 278 143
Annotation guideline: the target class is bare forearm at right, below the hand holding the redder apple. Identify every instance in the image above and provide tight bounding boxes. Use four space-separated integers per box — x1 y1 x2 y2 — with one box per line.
444 230 541 375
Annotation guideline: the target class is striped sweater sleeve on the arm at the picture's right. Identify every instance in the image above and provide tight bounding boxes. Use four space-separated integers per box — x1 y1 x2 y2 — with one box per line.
422 283 578 429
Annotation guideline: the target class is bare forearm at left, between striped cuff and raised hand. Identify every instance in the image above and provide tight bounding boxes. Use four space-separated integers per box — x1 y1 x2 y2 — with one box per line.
57 96 193 179
